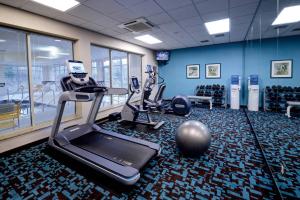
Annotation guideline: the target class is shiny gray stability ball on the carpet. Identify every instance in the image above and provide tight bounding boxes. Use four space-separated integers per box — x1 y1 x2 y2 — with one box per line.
175 120 211 156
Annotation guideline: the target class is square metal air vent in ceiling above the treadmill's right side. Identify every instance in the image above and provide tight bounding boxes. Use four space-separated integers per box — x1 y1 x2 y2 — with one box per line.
119 18 153 33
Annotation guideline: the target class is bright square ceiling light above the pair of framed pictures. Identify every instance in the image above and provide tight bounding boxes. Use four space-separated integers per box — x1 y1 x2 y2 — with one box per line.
205 18 230 35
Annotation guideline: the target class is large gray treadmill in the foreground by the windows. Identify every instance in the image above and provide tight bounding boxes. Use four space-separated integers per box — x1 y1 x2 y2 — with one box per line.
48 60 161 185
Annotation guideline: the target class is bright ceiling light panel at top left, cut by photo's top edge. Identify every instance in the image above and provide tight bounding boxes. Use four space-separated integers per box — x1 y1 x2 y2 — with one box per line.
31 0 79 12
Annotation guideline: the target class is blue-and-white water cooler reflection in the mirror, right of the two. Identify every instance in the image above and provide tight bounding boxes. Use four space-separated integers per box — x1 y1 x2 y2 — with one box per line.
248 75 259 111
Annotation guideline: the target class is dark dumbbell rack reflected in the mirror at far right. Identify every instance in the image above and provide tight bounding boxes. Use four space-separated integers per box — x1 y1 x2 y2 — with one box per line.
264 85 300 112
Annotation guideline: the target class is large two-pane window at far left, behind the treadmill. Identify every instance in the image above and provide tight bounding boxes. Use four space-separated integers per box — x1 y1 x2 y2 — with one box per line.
0 27 75 138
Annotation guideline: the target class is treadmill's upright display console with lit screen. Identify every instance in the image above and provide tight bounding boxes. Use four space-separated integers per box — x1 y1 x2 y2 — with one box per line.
67 60 89 85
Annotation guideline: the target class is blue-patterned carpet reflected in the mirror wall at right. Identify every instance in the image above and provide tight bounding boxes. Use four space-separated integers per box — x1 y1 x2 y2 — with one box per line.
248 112 300 199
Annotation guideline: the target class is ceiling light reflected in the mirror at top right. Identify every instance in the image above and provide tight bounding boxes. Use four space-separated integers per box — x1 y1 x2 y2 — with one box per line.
272 5 300 26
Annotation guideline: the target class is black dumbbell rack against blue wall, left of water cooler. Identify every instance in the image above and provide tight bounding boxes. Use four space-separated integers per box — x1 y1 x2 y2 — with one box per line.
194 84 227 108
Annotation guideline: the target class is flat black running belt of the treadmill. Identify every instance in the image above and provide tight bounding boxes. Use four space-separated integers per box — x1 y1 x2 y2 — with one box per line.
70 132 156 170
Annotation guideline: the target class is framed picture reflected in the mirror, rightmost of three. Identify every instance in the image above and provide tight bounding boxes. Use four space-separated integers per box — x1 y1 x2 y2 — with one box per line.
271 60 293 78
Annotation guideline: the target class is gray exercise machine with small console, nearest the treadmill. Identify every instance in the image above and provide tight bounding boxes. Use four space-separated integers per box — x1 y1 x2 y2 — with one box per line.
120 76 165 129
